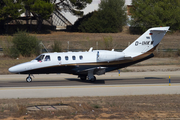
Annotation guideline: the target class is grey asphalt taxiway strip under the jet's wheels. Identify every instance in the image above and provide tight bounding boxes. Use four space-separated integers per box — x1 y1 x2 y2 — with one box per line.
0 71 180 99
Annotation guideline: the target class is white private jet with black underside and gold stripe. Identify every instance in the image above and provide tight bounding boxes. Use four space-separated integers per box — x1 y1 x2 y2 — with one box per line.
9 27 169 82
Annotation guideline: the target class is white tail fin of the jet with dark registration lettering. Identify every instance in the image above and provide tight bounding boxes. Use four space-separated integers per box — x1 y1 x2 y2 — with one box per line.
123 27 170 57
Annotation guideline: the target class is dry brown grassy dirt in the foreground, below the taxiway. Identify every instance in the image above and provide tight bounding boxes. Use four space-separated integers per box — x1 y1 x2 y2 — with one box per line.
0 95 180 120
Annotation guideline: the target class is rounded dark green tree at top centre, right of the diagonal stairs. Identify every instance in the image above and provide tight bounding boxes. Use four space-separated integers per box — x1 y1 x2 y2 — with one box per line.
72 0 127 33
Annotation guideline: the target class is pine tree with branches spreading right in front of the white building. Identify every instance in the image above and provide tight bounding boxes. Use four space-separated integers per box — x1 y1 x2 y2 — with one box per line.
23 0 92 31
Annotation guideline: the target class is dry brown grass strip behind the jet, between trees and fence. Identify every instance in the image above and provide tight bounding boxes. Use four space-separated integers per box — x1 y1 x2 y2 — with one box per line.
0 31 180 51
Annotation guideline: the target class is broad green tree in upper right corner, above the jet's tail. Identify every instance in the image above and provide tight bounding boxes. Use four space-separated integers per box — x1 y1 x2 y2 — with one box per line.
130 0 180 32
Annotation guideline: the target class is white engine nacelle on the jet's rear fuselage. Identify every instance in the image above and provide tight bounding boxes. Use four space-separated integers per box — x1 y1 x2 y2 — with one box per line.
97 51 125 62
